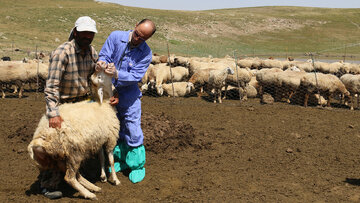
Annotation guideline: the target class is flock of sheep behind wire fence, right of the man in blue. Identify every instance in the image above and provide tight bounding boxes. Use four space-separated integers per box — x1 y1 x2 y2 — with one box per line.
143 55 360 110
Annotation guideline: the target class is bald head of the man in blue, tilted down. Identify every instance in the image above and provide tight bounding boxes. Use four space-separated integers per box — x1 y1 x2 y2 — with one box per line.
131 19 156 46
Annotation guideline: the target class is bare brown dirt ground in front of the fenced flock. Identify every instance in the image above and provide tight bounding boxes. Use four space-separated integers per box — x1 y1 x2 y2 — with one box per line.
0 92 360 202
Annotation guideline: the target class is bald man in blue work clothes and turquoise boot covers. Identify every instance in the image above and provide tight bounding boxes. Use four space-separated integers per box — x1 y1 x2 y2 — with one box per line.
97 19 156 183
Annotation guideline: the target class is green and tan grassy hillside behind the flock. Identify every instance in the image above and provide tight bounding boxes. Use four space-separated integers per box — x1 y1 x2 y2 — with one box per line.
0 0 360 58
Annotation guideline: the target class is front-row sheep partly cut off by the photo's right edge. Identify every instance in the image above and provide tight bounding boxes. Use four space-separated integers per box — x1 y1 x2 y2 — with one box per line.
340 74 360 110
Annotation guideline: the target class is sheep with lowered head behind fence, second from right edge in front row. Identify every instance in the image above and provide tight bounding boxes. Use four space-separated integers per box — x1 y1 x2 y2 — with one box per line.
300 73 350 107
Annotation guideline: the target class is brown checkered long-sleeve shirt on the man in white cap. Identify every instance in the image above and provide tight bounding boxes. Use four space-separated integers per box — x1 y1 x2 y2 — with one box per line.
44 40 98 118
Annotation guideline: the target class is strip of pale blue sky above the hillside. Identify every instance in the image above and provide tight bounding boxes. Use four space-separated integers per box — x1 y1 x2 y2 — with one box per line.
97 0 360 11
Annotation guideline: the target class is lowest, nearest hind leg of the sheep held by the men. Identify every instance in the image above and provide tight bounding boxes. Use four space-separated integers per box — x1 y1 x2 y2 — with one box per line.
64 163 97 200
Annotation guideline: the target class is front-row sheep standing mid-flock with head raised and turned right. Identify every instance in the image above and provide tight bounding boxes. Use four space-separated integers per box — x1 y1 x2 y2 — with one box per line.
209 67 234 104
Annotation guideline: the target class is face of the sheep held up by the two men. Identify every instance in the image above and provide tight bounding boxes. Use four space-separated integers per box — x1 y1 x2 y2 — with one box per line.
91 70 112 103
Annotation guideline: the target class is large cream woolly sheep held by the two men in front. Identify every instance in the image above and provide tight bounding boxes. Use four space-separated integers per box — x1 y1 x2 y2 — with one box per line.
28 71 120 199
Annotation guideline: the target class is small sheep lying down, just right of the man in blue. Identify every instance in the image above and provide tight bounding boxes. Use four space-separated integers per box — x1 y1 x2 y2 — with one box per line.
159 82 194 97
